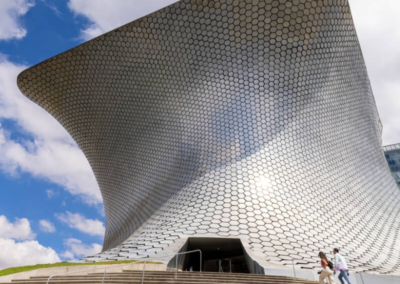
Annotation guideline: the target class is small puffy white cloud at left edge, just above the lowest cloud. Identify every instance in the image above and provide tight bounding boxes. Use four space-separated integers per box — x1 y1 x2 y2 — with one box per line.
0 215 36 240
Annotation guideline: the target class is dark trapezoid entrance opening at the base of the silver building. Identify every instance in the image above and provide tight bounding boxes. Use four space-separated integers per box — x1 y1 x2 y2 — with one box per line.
182 238 249 273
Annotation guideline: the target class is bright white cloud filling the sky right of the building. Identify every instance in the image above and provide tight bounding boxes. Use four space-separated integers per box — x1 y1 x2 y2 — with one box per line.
350 0 400 145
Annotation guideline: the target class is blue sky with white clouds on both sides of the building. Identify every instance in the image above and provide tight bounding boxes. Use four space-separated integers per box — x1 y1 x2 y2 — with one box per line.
0 0 400 269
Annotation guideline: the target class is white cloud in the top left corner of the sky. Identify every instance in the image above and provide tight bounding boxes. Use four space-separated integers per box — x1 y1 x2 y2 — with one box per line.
0 0 35 40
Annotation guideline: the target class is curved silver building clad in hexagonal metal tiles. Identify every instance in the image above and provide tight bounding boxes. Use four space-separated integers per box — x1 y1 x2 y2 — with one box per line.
18 0 400 273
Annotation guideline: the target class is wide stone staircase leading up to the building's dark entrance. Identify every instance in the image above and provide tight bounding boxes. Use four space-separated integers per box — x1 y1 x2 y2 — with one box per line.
0 270 317 284
